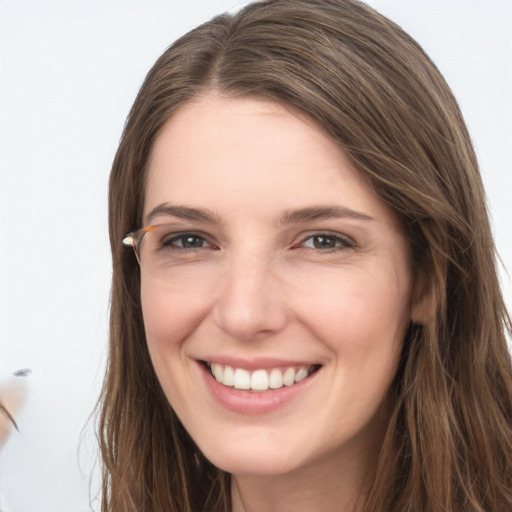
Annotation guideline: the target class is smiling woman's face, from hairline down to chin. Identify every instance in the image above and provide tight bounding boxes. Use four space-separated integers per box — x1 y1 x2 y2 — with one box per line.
141 94 422 475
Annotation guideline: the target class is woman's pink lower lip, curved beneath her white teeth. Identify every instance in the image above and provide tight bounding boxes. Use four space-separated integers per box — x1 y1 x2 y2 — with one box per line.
198 363 318 415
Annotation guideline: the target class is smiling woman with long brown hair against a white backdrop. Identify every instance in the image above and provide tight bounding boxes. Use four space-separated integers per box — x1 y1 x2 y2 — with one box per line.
100 0 512 512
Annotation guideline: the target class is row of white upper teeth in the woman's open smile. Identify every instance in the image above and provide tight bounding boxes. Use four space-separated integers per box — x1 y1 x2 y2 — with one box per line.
209 363 311 391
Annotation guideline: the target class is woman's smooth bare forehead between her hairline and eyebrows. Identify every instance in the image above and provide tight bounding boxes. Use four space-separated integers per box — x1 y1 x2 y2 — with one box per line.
144 94 391 228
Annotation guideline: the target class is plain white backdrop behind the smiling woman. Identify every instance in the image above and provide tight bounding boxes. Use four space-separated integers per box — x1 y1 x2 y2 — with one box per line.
0 0 512 512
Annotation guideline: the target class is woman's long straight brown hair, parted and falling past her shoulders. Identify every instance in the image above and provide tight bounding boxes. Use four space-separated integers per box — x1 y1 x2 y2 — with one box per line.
99 0 512 512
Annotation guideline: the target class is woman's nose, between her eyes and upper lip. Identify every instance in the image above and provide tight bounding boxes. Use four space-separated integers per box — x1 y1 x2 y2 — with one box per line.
213 252 287 341
